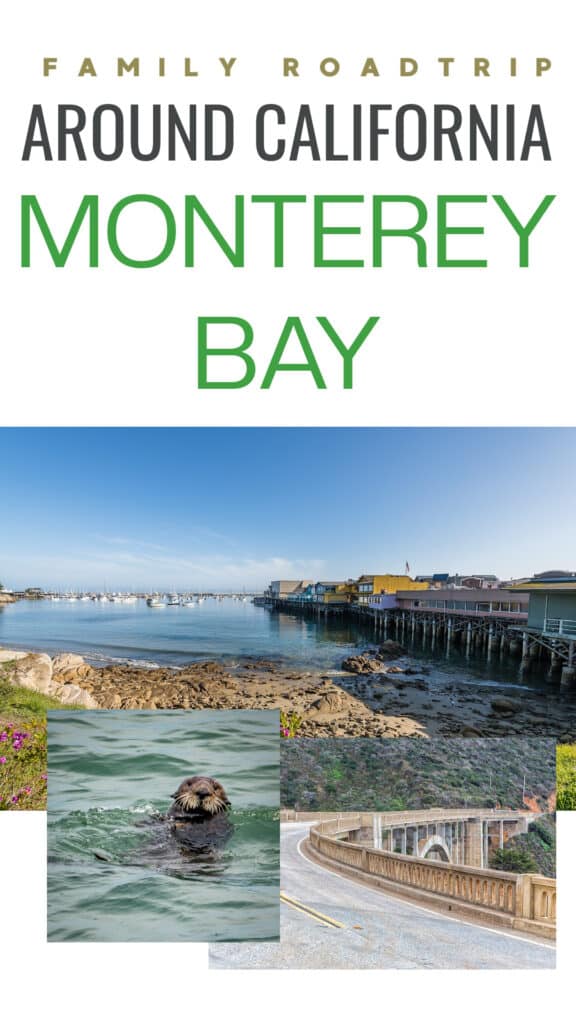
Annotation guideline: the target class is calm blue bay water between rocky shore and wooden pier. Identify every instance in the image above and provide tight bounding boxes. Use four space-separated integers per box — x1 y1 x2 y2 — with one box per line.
0 598 544 688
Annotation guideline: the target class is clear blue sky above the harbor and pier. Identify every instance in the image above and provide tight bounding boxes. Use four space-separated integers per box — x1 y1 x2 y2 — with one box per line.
0 428 576 590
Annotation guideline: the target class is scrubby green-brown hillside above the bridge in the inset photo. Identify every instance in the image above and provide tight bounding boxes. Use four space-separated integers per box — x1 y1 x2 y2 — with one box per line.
281 738 556 811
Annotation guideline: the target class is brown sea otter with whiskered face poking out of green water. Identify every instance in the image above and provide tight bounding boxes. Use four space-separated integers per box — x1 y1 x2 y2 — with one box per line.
166 775 233 853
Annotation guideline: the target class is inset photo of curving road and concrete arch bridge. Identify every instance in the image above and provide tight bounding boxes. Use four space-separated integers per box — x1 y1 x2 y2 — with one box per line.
210 738 557 970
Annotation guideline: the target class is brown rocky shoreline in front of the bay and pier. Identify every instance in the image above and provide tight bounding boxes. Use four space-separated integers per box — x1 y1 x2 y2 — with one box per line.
0 641 576 742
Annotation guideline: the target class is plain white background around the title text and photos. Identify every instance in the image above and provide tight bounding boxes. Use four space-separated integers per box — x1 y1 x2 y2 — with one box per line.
0 0 576 1024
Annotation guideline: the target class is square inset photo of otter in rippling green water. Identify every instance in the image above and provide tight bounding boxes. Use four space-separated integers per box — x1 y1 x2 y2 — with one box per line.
47 710 280 942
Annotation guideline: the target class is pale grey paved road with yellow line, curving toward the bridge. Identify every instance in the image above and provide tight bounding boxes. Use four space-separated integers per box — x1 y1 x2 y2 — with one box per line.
210 825 556 970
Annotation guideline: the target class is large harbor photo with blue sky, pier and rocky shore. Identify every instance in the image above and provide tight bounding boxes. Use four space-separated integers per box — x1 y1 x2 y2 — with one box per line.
0 428 576 810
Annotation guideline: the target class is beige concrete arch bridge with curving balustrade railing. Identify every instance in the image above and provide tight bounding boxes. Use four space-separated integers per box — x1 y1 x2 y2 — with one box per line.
306 808 556 938
